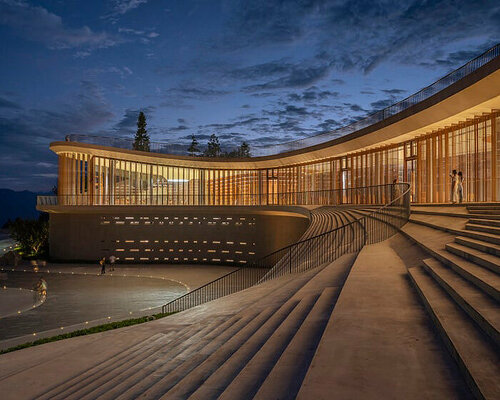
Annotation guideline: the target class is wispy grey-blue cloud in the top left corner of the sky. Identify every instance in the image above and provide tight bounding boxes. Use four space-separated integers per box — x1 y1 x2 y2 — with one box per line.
0 0 118 50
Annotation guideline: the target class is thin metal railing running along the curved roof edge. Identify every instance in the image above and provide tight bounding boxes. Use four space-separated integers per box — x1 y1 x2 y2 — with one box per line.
66 43 500 157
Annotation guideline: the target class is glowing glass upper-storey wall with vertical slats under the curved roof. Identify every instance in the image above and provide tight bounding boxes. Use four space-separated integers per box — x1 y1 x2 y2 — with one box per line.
58 113 500 205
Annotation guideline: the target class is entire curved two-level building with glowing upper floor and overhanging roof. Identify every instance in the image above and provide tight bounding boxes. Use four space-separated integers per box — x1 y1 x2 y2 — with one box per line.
38 45 500 263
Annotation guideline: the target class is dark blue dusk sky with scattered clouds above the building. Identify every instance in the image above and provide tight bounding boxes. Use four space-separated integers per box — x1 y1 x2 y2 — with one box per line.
0 0 500 191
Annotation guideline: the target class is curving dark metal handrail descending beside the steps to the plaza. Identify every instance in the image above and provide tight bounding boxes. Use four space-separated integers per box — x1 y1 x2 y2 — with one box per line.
162 183 410 312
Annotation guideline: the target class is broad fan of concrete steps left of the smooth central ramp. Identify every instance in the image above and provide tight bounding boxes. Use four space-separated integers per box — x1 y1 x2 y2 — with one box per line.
30 207 382 400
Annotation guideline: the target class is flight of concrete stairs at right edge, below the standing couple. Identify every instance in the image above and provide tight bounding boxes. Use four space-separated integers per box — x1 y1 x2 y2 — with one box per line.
402 204 500 399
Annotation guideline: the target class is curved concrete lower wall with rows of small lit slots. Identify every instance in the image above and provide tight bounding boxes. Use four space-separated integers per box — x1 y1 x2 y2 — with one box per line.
50 206 309 265
